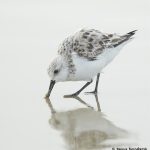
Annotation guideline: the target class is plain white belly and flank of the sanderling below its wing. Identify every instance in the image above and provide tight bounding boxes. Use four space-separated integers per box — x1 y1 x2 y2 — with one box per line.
72 47 122 81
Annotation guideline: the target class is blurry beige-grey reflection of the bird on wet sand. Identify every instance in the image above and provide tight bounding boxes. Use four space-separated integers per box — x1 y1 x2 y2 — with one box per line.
46 95 128 150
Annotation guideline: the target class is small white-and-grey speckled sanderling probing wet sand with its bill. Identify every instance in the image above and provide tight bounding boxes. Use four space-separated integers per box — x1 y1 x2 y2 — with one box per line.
46 29 136 97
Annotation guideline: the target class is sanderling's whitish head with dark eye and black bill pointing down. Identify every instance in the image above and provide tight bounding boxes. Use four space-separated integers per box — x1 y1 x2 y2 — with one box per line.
47 56 68 97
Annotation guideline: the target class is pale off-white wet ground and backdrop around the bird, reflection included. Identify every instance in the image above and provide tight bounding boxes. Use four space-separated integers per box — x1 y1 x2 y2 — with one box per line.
0 0 150 150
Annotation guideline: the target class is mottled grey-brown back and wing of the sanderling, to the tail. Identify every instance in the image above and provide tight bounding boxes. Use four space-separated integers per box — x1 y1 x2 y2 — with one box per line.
59 29 135 60
